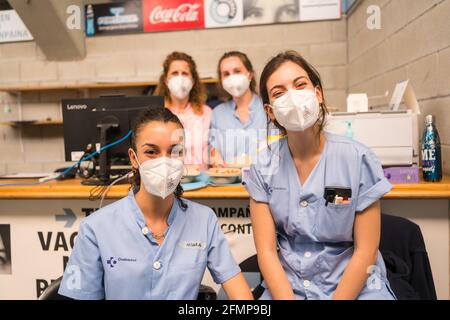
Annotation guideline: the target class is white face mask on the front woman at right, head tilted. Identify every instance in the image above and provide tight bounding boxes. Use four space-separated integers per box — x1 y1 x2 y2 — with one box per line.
272 89 320 131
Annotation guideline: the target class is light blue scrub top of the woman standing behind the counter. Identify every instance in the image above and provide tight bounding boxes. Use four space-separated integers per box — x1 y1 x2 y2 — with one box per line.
209 94 267 163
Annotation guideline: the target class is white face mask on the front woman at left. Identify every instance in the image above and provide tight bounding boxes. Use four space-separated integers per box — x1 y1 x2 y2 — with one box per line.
133 151 184 199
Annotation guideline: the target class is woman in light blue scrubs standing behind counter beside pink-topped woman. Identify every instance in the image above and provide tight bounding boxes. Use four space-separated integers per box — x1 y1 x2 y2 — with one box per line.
209 51 267 167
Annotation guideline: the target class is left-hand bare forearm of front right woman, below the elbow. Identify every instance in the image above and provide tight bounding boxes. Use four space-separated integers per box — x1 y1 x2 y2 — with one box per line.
258 252 295 300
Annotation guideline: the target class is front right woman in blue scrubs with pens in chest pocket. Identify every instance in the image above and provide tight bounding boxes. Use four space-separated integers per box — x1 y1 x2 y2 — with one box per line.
246 51 394 299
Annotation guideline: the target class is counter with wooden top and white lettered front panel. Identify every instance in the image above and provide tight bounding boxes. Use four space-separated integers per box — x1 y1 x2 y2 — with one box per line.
0 177 450 299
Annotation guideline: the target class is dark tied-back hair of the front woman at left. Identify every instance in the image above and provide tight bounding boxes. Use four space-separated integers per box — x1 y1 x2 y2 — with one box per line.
130 107 187 209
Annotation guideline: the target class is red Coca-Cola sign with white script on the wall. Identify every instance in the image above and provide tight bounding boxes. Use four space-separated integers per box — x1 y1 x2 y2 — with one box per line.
143 0 205 32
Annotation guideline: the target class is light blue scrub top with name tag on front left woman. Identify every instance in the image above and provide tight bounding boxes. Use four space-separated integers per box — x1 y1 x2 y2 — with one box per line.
59 191 240 300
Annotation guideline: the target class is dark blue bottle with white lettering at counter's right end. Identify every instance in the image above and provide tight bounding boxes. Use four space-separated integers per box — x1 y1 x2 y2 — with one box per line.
422 115 442 182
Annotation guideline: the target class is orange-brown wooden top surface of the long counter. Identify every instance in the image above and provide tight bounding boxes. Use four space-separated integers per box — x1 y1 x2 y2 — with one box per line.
0 176 450 199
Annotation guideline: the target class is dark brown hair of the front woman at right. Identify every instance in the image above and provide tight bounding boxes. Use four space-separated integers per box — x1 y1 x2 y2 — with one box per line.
259 50 328 134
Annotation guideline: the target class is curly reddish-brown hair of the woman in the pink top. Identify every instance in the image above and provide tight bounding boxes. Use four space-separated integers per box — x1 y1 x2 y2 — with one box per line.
154 51 206 115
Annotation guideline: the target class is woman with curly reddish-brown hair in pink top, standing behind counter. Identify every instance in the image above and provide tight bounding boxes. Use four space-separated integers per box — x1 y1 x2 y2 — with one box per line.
155 51 211 169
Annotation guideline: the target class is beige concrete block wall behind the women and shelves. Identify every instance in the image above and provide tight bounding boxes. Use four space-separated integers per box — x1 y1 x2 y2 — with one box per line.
0 0 450 173
